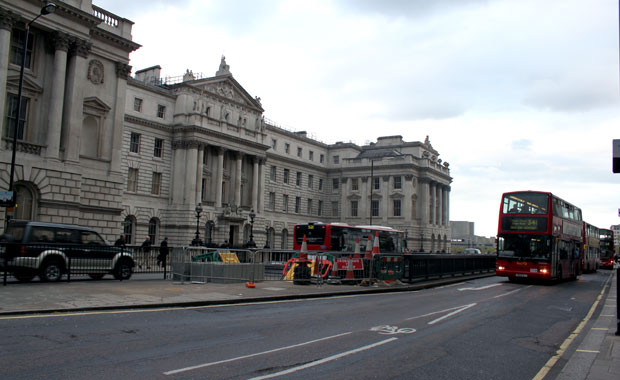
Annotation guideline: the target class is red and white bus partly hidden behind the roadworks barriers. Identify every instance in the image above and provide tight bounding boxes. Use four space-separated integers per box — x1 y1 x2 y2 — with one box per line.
293 222 406 253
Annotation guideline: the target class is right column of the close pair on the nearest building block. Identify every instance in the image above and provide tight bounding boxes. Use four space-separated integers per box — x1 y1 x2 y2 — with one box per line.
61 40 91 162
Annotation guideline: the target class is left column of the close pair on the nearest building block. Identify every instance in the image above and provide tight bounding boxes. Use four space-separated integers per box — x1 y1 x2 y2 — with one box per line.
45 33 69 160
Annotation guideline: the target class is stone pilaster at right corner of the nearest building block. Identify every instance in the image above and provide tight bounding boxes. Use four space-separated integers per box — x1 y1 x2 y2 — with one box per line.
110 62 131 173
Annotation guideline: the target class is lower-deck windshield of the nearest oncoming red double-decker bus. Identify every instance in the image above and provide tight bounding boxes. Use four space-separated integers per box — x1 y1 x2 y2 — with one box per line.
497 234 551 260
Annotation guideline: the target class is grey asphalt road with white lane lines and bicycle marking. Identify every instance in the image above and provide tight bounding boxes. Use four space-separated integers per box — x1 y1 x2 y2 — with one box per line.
0 271 609 380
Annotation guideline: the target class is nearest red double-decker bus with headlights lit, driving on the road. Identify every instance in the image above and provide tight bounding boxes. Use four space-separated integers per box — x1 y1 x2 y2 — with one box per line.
495 191 583 281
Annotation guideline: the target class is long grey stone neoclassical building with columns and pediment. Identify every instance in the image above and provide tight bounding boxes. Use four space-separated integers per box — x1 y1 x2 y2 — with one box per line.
0 0 452 252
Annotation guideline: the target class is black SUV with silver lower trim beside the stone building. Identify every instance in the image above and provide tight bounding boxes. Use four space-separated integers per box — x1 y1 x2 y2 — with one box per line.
0 221 134 281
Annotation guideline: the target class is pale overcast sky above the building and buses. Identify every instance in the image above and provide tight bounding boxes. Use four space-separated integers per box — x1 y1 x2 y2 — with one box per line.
94 0 620 236
